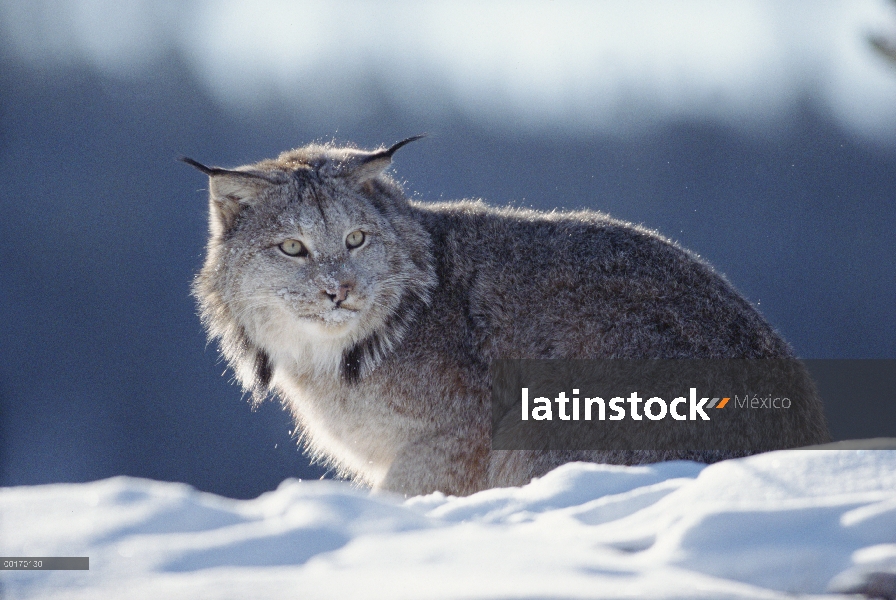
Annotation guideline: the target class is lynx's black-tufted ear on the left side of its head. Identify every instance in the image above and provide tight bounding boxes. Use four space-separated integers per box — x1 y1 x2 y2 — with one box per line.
180 157 276 235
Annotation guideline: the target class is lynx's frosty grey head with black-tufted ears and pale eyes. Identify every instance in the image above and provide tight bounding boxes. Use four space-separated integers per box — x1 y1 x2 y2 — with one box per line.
183 136 435 401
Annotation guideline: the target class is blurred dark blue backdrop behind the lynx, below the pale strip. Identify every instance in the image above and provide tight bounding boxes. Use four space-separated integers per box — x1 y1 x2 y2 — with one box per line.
0 1 896 498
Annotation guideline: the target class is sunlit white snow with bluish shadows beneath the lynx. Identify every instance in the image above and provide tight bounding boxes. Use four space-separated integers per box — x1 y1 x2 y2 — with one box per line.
0 450 896 599
